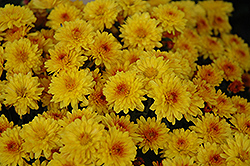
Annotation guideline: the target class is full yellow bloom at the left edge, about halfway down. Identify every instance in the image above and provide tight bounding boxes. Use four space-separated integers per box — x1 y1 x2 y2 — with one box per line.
1 73 43 118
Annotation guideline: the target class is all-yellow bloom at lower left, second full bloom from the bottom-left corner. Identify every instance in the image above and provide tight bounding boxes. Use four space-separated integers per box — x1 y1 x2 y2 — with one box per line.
20 116 62 159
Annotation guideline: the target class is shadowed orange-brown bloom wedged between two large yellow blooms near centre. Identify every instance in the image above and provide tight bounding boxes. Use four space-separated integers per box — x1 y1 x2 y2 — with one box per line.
88 83 111 115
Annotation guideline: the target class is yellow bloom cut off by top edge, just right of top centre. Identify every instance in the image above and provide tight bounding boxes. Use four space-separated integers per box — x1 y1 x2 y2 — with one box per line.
117 0 149 18
